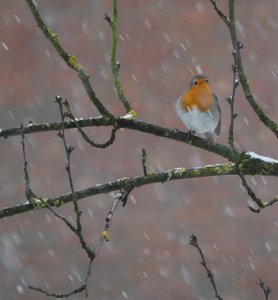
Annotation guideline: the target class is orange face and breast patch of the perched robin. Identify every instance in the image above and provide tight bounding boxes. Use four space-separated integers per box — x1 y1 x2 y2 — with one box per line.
182 83 213 112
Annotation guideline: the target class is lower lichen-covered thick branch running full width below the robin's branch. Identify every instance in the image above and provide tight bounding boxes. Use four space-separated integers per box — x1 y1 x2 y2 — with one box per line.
0 153 278 218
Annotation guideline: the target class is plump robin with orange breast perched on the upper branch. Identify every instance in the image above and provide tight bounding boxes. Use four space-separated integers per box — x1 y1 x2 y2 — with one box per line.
177 75 221 143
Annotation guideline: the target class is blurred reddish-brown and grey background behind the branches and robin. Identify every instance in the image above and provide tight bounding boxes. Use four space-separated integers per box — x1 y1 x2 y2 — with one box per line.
0 0 278 300
